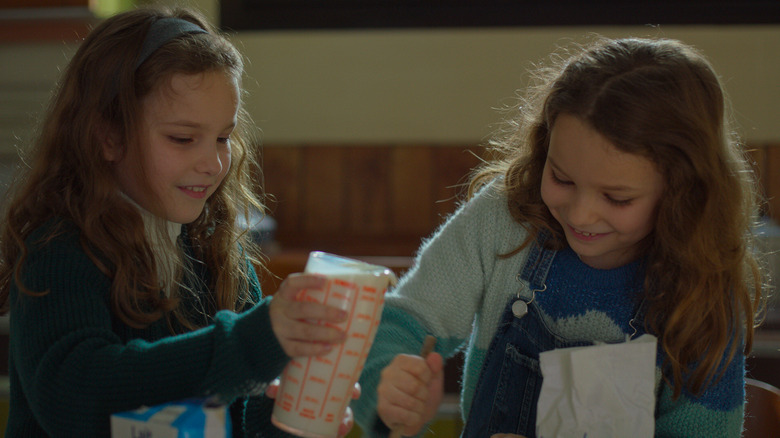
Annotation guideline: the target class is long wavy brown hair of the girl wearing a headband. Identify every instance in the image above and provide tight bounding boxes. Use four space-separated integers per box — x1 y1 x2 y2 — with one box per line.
0 8 265 328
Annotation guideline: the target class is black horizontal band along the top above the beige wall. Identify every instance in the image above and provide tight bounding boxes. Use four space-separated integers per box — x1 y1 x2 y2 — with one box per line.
220 0 780 31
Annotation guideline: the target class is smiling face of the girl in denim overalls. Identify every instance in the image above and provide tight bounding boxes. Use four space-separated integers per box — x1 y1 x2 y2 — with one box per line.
541 114 664 269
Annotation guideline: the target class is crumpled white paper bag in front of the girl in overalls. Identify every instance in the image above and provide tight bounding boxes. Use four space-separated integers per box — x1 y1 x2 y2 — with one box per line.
536 335 656 438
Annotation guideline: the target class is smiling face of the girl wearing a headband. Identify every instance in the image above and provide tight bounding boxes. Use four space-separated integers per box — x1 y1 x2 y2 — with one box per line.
106 71 239 224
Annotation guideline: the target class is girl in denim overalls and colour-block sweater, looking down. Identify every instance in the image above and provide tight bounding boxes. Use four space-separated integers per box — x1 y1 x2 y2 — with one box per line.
355 39 761 437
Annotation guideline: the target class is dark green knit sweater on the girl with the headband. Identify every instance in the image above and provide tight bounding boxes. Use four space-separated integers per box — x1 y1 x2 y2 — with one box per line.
6 223 296 437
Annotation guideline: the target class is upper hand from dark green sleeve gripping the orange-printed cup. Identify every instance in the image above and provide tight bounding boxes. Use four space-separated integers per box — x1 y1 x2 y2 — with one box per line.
269 274 347 357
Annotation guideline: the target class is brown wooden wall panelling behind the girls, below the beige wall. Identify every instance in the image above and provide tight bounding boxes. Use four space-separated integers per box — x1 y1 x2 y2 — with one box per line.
263 144 780 258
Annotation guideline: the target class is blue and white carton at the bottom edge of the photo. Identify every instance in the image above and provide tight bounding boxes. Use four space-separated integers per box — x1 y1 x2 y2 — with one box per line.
111 398 232 438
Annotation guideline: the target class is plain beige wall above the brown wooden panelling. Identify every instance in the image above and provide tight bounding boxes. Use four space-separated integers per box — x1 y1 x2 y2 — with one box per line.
0 0 780 152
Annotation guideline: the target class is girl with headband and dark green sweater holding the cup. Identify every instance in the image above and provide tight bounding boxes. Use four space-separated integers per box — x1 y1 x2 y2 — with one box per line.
0 9 349 437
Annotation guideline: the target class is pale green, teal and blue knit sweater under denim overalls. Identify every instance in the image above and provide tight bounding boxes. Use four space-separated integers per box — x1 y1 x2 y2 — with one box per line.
353 180 744 437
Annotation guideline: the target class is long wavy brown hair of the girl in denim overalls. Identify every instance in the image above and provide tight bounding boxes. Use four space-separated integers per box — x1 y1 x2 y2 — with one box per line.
469 38 764 398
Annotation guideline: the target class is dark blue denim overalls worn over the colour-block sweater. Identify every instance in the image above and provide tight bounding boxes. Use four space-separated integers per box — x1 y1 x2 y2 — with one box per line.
461 236 590 438
